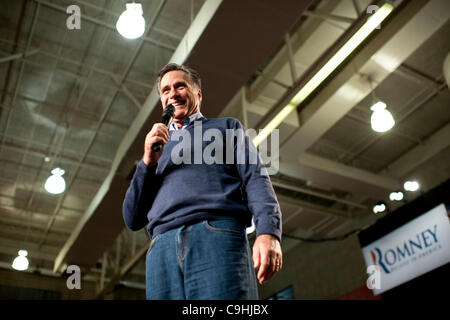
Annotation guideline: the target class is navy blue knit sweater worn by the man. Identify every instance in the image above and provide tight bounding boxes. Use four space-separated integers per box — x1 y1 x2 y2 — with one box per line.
123 118 281 241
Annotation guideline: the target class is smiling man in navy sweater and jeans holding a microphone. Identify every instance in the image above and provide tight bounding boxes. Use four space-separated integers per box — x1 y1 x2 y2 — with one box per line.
123 64 282 300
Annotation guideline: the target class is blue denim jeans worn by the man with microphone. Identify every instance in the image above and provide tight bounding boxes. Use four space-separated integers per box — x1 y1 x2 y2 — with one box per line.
146 219 258 300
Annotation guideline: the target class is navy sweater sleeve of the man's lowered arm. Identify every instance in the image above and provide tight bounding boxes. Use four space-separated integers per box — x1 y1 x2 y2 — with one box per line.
235 120 282 242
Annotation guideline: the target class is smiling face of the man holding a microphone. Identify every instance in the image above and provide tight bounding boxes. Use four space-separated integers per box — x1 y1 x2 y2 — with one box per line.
160 70 202 121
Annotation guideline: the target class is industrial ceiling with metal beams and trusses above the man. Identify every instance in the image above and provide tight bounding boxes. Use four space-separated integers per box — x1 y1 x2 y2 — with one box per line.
0 0 450 294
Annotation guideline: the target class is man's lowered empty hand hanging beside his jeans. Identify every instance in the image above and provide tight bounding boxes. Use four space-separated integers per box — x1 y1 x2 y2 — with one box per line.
253 234 283 284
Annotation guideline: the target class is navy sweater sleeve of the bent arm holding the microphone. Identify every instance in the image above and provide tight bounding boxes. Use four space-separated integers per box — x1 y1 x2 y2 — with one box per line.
122 160 157 231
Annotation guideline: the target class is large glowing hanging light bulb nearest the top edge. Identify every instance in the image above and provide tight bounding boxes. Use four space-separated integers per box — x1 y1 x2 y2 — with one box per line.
116 2 145 39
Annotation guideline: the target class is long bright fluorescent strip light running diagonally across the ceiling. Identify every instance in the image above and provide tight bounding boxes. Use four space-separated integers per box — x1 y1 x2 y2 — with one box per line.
253 3 394 146
